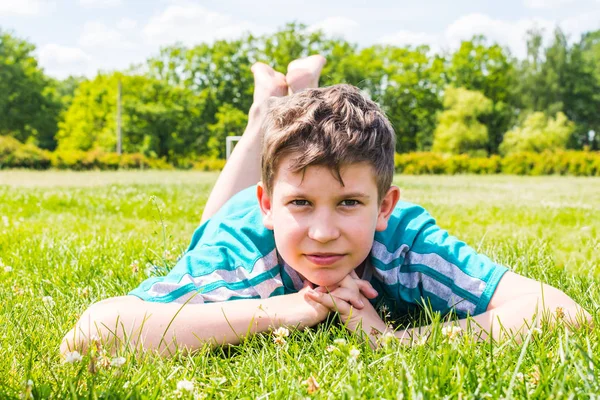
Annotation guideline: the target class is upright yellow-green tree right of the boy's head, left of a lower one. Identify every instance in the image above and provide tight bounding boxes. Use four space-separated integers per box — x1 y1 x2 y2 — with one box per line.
432 87 493 155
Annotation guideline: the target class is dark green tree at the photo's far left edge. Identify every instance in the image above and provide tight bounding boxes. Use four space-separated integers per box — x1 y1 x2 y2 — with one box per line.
0 30 60 149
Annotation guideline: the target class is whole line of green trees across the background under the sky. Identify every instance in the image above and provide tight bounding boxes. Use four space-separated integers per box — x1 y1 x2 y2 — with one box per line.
0 23 600 165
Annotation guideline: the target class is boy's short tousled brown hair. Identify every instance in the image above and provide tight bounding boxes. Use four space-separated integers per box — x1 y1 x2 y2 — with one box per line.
261 84 396 201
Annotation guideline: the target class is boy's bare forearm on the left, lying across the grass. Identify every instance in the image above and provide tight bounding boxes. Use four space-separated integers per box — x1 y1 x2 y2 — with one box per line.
61 288 329 355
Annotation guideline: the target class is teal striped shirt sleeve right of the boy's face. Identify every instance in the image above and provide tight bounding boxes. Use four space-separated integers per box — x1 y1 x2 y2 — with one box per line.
372 202 507 317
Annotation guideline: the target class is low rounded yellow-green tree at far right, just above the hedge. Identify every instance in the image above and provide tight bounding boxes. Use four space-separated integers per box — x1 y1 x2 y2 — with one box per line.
500 112 575 154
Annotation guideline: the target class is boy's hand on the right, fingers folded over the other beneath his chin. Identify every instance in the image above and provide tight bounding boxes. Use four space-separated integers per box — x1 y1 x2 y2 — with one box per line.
307 271 385 337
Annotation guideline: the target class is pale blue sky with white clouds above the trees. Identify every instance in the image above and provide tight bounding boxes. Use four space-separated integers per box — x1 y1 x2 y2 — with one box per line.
0 0 600 78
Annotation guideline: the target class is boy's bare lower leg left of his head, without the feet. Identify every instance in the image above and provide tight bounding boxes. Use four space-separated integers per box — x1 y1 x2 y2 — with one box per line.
201 105 263 223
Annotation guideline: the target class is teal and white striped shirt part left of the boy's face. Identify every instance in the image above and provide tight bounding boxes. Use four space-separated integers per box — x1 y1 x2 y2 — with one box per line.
129 188 285 303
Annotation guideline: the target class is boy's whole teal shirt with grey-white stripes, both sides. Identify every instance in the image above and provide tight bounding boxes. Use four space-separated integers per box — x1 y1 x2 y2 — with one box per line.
130 186 507 317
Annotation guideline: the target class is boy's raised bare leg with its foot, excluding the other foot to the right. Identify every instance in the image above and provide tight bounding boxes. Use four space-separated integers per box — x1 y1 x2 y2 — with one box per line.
201 62 288 223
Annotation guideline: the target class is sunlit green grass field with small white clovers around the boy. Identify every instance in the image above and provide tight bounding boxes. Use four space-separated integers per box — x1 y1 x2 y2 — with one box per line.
0 171 600 399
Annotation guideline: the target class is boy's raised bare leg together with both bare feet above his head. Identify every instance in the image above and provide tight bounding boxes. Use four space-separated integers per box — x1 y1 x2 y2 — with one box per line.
201 55 325 222
